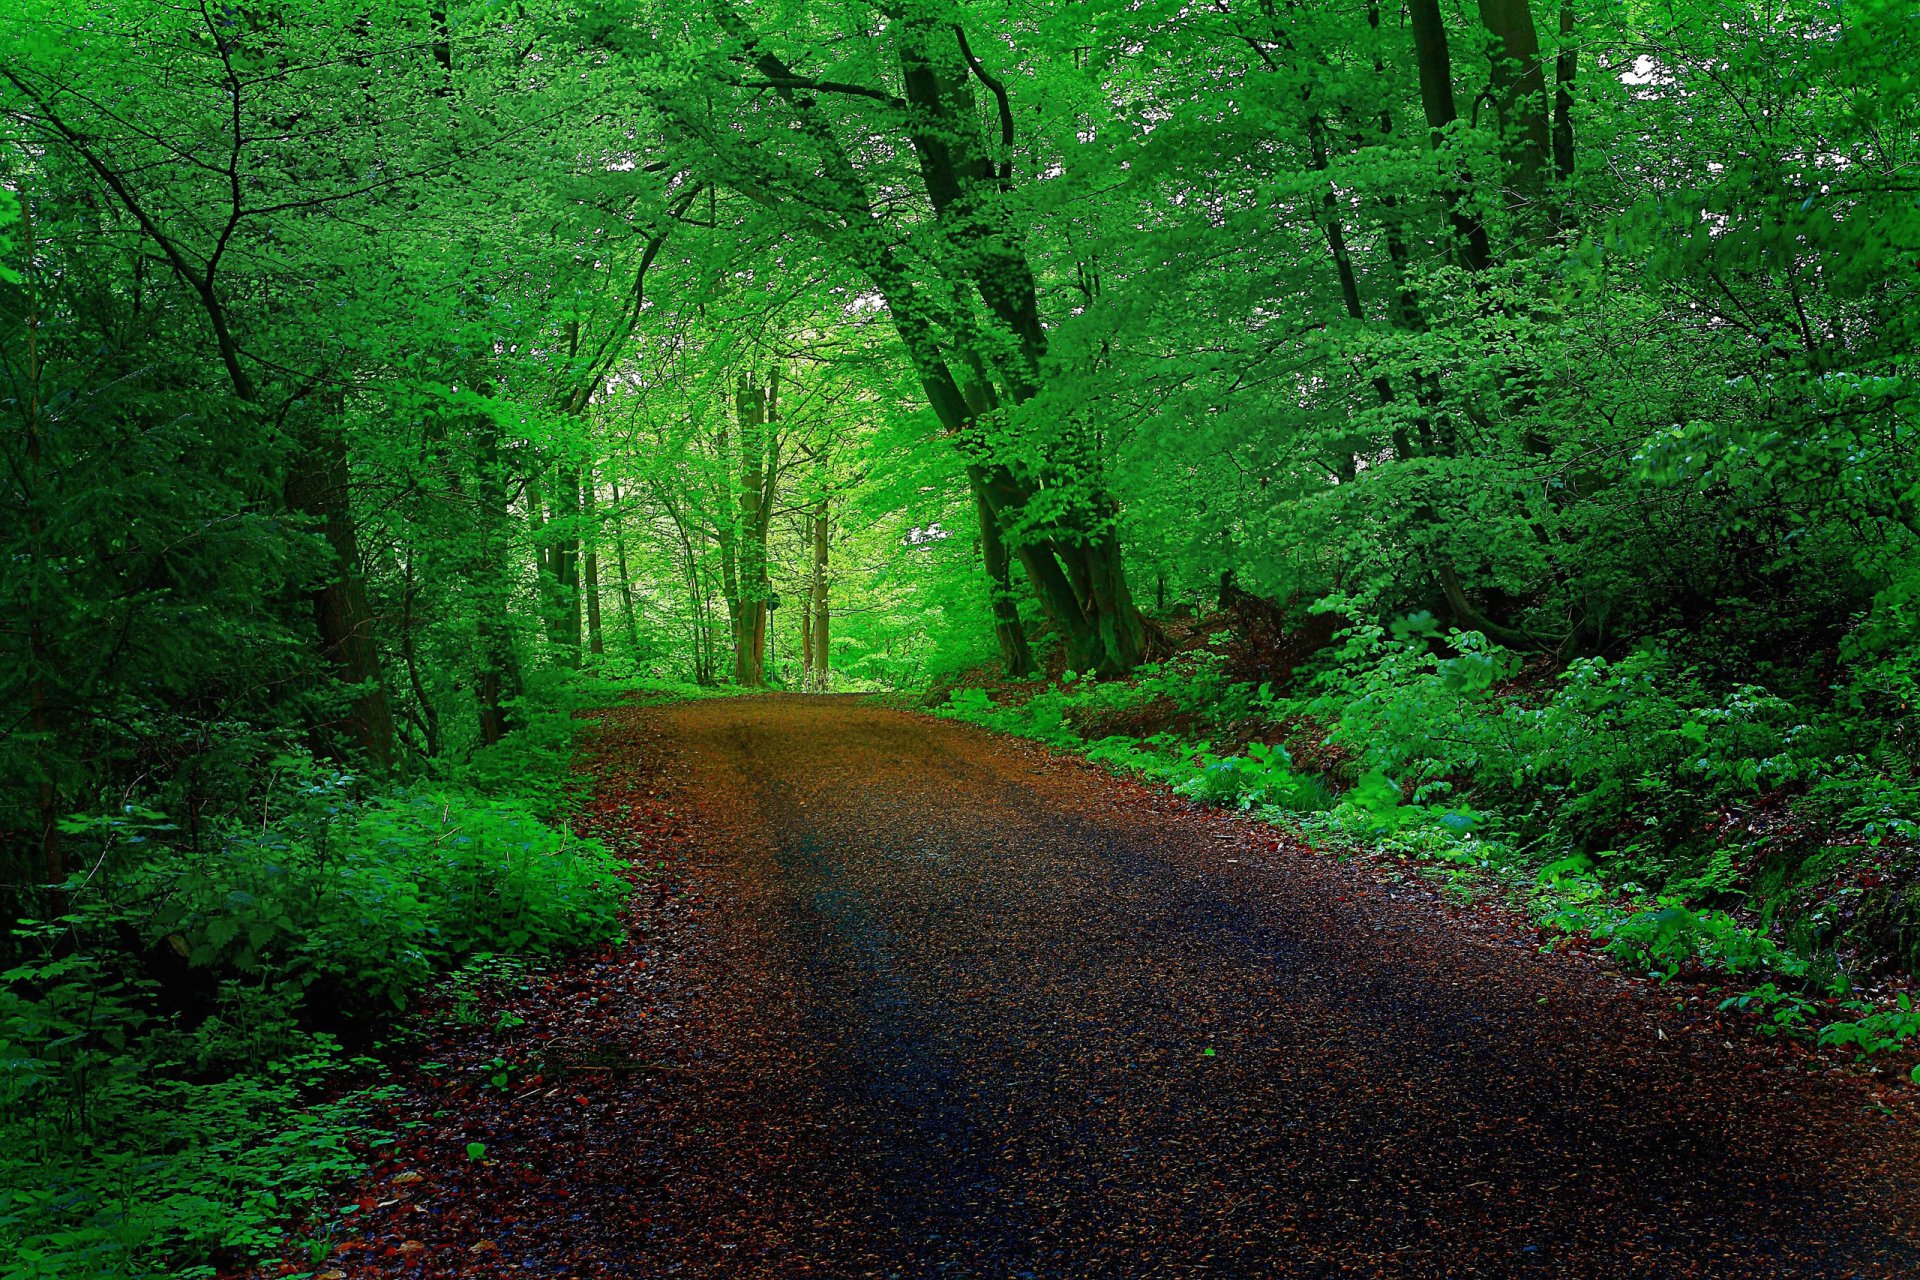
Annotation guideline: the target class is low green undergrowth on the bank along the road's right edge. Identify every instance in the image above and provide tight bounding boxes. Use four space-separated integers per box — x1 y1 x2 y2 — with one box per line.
929 616 1920 1080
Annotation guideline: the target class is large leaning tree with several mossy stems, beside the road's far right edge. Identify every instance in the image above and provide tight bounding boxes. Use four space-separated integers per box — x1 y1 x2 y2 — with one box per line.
603 2 1146 674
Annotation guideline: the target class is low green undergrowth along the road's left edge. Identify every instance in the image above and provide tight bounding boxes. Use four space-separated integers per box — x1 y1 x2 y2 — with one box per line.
0 674 707 1280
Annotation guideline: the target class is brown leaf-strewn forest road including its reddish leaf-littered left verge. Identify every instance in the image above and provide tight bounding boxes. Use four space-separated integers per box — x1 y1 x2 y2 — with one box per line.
288 695 1920 1280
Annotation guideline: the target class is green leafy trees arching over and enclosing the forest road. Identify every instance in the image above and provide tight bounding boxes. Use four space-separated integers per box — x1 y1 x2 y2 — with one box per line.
0 0 1920 1274
